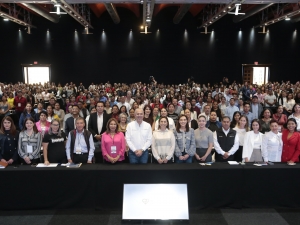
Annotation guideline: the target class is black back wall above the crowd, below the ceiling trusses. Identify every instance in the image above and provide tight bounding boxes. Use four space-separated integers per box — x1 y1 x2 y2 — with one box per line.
0 7 300 84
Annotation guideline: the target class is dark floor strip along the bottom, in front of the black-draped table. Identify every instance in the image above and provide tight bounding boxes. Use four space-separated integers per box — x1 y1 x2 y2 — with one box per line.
0 209 300 225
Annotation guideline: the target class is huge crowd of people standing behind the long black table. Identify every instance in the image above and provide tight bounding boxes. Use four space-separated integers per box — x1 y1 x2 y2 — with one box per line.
0 78 300 165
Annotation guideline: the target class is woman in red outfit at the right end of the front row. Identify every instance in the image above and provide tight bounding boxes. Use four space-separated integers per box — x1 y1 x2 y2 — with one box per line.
281 118 300 163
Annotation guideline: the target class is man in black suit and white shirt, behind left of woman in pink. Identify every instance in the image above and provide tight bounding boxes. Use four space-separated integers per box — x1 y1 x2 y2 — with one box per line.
88 102 110 163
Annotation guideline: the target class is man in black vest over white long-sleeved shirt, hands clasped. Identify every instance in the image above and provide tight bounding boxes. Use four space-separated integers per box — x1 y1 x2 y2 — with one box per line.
213 116 239 162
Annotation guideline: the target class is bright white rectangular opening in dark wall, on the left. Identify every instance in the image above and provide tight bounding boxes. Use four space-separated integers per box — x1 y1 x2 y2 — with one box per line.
24 67 50 84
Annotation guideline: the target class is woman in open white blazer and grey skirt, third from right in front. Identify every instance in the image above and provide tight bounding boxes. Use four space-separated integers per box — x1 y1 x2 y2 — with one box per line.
242 119 263 162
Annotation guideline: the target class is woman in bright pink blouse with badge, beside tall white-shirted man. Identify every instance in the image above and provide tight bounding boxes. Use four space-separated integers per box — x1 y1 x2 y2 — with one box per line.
101 118 126 164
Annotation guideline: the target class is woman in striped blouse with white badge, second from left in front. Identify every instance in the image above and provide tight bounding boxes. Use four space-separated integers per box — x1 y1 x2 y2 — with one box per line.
18 117 42 164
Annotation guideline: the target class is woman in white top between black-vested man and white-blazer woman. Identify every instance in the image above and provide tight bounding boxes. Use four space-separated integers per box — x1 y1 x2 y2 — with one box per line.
233 116 249 162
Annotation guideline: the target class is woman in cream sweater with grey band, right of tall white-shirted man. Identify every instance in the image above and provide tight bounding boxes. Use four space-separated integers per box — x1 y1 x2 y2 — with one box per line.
152 116 175 164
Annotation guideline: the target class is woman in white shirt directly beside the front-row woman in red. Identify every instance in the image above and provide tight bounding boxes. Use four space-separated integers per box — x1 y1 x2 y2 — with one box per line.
261 120 282 162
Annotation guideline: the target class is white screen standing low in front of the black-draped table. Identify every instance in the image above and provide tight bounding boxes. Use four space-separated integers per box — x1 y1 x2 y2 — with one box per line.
122 184 189 220
